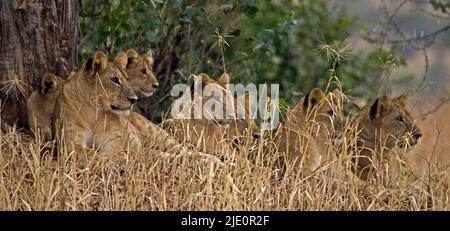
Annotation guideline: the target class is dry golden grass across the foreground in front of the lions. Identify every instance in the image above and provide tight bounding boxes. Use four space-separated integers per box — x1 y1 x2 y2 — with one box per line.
0 99 450 210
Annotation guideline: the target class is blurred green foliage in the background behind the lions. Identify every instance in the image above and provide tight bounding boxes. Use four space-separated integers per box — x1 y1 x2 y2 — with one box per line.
78 0 450 122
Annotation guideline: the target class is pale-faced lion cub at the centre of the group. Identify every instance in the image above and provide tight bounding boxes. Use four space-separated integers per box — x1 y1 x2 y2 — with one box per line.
163 74 256 154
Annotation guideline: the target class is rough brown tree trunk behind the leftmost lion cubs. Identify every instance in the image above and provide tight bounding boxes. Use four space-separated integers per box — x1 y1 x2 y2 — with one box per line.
0 0 81 128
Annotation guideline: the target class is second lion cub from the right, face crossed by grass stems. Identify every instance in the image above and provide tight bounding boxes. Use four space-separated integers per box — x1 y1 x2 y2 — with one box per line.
274 88 345 171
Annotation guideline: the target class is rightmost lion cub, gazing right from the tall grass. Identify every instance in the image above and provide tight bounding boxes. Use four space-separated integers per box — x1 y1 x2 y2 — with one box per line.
353 94 422 180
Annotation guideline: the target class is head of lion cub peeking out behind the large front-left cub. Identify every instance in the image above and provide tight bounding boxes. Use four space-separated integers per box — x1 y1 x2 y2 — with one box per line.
114 49 159 97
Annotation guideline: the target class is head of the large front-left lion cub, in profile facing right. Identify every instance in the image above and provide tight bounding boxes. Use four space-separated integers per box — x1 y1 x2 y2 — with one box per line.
83 51 137 116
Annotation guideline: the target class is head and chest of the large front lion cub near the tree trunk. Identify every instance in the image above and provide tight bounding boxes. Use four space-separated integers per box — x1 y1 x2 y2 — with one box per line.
52 51 140 152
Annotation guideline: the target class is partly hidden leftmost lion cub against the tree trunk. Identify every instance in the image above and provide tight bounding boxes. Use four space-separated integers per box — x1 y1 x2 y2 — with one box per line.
27 73 65 136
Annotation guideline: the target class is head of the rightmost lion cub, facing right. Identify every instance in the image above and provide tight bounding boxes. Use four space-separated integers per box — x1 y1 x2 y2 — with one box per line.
360 94 422 148
